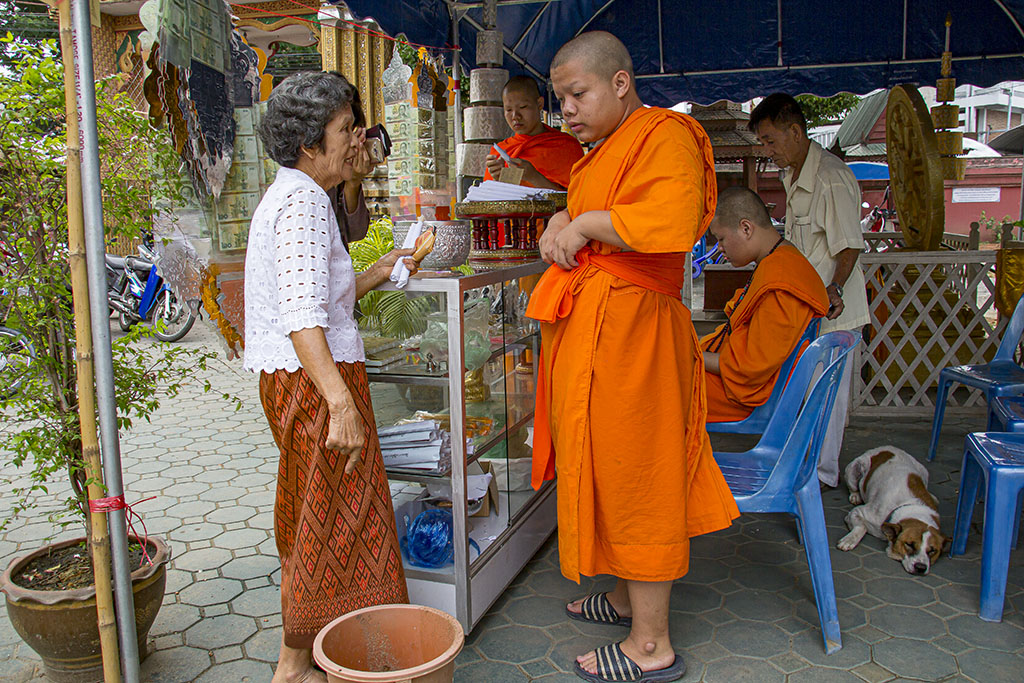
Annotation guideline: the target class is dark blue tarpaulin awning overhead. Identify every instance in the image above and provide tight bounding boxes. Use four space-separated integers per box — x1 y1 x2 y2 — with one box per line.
333 0 1024 105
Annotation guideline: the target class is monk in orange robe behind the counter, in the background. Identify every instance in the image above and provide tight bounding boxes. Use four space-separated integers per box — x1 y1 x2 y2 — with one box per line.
483 76 583 189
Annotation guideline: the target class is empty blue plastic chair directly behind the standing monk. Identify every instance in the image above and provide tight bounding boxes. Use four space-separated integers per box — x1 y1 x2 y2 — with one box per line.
715 331 857 654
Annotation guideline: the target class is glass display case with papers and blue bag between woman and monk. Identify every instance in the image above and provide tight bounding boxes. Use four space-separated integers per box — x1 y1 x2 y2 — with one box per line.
358 261 556 633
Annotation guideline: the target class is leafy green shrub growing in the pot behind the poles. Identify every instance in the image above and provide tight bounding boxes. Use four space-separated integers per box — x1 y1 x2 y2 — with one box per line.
0 35 232 528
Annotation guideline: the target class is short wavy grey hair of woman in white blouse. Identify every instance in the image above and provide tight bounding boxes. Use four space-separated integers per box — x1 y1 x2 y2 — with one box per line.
259 71 366 168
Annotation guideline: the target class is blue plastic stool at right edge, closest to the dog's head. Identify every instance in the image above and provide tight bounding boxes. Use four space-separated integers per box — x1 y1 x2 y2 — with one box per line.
949 432 1024 622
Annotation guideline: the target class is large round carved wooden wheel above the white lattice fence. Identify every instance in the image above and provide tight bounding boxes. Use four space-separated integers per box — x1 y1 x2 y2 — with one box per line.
886 85 945 251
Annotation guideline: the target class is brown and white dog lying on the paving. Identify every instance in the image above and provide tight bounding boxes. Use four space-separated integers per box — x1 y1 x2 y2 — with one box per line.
838 445 950 574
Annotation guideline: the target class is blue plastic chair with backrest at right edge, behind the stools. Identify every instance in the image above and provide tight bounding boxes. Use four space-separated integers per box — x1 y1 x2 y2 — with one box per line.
928 296 1024 462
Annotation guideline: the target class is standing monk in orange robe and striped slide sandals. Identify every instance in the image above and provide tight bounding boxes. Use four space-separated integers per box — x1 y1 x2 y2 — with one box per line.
527 32 739 681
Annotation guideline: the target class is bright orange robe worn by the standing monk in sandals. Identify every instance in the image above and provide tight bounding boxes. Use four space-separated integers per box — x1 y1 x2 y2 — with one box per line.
526 108 738 581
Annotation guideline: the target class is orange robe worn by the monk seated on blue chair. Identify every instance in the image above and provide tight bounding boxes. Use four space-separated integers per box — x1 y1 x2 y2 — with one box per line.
700 240 828 422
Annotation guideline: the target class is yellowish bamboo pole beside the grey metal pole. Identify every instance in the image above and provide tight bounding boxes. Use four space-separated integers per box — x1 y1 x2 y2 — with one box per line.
57 0 121 683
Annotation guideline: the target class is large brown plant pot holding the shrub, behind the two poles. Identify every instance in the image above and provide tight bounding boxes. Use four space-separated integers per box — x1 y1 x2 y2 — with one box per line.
0 537 171 683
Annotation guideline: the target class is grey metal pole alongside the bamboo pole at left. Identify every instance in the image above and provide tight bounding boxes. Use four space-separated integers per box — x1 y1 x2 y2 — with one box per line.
72 0 139 683
